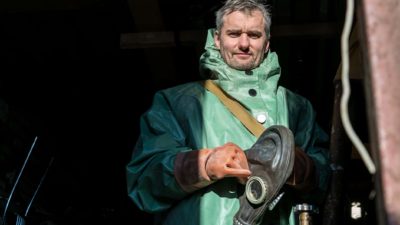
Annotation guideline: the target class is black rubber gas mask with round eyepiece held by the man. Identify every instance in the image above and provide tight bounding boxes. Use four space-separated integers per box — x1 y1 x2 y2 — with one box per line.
233 125 295 225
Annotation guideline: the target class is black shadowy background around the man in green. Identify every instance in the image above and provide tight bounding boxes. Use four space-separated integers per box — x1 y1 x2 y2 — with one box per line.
0 0 376 225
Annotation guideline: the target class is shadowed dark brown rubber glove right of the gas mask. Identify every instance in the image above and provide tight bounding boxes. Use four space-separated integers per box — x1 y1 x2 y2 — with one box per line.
286 146 318 192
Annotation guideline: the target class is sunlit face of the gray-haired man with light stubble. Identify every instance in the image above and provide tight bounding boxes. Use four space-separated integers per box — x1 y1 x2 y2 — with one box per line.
214 10 269 70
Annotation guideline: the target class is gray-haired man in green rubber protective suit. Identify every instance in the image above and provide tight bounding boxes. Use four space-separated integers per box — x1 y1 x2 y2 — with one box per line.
127 0 329 225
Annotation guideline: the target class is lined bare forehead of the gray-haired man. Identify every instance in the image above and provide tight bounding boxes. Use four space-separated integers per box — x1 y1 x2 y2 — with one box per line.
222 10 265 32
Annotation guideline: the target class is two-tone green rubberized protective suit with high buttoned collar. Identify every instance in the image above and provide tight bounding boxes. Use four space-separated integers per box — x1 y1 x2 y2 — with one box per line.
126 29 330 225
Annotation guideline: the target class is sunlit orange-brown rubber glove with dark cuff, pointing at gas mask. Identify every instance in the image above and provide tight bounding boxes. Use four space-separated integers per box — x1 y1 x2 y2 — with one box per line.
174 143 251 192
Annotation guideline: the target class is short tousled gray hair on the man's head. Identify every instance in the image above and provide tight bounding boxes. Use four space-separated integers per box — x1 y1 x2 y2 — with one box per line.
215 0 271 39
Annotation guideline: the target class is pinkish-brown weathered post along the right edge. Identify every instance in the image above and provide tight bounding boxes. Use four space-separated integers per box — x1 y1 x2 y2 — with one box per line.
359 0 400 225
